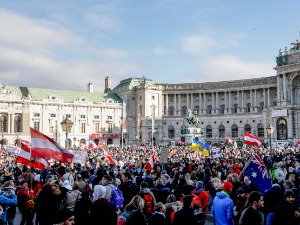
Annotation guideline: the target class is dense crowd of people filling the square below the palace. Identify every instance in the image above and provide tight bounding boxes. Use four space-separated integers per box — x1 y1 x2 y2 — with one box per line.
0 143 300 225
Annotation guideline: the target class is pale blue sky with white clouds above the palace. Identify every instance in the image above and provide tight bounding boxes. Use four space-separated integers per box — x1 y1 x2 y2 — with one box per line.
0 0 300 92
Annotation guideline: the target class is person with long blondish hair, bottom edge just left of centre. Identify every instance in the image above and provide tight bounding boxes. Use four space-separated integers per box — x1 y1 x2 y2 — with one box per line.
118 195 147 225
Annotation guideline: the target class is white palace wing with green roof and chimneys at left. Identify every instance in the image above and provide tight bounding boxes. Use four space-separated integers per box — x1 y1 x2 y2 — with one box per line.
0 77 123 147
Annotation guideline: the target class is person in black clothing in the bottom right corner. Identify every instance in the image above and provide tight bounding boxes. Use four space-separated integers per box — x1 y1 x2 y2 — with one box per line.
272 190 300 225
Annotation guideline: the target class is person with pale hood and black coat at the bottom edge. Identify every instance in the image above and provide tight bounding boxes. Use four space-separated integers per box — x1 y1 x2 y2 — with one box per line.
86 185 117 225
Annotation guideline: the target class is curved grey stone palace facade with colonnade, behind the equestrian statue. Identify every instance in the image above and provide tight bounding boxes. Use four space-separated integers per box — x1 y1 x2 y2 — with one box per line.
113 42 300 146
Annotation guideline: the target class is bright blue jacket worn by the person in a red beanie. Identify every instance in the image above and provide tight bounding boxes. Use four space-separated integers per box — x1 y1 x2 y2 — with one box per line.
212 191 234 225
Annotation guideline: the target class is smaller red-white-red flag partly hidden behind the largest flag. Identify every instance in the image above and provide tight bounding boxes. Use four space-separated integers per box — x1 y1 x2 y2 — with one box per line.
16 140 50 170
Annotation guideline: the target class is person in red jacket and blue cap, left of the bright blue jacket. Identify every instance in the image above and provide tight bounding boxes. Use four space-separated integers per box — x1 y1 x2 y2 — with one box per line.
192 181 209 225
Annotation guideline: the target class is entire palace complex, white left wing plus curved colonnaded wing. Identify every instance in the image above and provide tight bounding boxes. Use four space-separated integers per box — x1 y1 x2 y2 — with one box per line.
0 41 300 147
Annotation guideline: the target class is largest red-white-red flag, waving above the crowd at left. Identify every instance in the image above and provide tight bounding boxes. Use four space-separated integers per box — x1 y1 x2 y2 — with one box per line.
30 128 74 163
